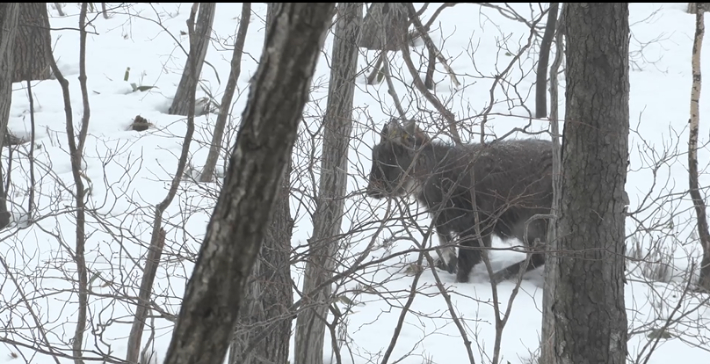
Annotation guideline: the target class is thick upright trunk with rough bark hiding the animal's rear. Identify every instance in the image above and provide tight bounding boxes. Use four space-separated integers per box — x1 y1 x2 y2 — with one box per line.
543 3 629 364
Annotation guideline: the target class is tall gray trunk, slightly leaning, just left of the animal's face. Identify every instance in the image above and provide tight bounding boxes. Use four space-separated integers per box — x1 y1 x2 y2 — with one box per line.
295 3 363 364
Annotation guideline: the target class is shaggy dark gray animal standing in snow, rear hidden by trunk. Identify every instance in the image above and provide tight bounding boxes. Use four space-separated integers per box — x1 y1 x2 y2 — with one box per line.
367 119 552 283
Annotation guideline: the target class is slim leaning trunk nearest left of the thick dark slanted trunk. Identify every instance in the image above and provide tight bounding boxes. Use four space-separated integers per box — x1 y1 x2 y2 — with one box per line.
200 3 251 182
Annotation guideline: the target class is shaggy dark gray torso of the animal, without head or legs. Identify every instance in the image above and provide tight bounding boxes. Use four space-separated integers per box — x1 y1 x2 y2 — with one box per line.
420 139 552 236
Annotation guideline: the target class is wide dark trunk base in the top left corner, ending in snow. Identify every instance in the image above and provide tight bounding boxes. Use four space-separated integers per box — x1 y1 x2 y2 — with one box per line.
12 3 52 82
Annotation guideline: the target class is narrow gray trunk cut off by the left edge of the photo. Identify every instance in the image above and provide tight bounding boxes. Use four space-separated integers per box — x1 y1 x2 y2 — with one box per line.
0 3 21 229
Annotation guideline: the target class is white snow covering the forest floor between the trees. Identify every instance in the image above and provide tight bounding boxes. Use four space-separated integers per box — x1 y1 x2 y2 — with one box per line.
0 3 710 364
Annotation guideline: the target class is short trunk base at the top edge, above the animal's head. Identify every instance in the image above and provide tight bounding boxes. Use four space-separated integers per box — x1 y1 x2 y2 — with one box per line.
358 3 409 51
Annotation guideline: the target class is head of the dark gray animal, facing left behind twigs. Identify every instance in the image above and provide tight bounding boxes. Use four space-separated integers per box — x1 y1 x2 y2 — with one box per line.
367 119 430 198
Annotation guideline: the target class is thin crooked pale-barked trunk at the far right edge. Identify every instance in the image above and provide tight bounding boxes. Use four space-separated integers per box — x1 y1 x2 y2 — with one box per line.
688 6 710 291
